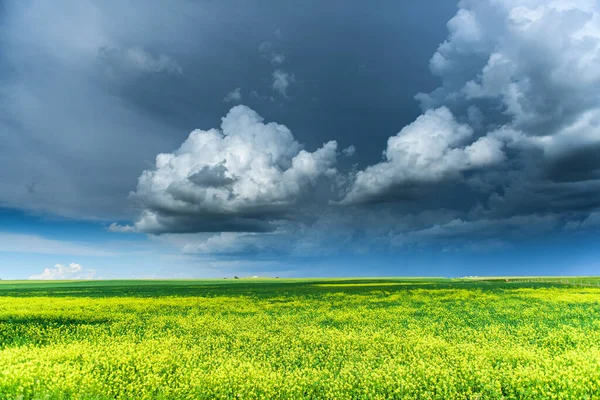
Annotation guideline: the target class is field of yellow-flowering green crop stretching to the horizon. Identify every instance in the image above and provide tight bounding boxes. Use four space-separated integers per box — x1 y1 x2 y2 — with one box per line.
0 278 600 400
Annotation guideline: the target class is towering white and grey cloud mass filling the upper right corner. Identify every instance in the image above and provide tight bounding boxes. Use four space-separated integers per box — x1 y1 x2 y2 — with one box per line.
342 0 600 218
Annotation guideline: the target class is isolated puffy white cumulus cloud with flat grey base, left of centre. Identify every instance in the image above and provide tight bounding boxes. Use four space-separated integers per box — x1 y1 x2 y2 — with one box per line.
131 106 337 233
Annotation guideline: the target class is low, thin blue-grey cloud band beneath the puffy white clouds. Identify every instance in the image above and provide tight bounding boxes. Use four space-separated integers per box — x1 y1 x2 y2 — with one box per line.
154 208 564 259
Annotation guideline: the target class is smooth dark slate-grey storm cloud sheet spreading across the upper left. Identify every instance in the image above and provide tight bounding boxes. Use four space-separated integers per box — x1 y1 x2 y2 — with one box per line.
0 0 453 219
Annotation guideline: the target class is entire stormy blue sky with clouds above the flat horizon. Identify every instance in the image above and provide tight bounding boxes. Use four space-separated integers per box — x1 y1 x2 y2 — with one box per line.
0 0 600 279
